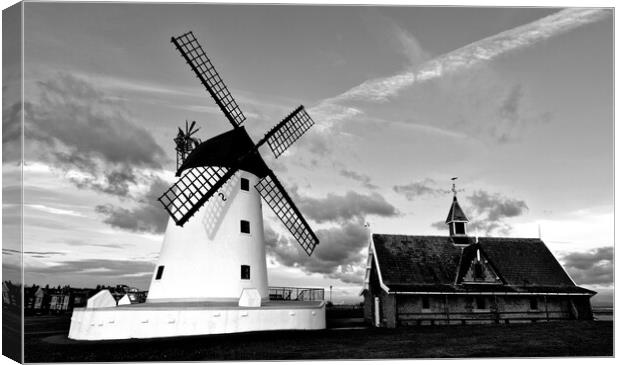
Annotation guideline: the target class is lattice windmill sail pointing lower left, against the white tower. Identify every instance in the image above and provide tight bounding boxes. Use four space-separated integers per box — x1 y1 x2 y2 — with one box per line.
158 167 237 226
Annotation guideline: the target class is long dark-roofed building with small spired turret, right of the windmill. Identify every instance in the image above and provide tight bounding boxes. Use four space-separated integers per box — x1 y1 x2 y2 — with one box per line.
362 192 596 327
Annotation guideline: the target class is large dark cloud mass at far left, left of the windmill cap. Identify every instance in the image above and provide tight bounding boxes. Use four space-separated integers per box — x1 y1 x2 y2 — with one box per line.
24 73 168 196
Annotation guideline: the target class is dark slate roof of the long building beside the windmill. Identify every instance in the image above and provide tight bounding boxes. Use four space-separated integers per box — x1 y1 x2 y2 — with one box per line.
372 234 595 294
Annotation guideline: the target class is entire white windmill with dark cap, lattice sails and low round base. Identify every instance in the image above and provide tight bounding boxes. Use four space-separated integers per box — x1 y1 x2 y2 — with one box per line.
69 32 325 340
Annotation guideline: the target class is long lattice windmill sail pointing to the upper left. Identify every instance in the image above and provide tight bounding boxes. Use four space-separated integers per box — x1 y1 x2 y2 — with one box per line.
172 32 245 128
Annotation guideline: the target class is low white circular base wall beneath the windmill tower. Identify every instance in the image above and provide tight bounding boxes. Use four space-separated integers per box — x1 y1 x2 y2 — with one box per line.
69 301 325 341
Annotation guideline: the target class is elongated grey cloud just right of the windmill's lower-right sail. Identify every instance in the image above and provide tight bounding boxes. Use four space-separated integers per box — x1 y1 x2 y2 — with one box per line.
291 188 399 223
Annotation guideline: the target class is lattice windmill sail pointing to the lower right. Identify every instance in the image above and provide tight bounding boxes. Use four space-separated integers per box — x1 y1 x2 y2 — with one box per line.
256 171 319 256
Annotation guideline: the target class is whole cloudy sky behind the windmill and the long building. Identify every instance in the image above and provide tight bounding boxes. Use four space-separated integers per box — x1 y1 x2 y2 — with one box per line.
3 3 613 303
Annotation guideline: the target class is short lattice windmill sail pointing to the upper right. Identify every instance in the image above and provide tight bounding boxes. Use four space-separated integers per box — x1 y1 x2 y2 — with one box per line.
258 105 314 158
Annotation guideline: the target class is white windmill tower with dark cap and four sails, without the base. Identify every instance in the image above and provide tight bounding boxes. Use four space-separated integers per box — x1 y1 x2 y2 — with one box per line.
149 32 319 299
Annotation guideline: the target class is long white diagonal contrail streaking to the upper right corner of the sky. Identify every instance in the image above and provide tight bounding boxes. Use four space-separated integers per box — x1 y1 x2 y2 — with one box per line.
311 8 611 122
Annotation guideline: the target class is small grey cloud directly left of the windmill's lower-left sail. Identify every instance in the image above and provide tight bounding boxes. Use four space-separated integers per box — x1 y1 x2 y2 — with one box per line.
95 178 168 233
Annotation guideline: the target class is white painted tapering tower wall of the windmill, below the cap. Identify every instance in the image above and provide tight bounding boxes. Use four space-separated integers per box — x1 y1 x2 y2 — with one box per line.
147 171 269 302
